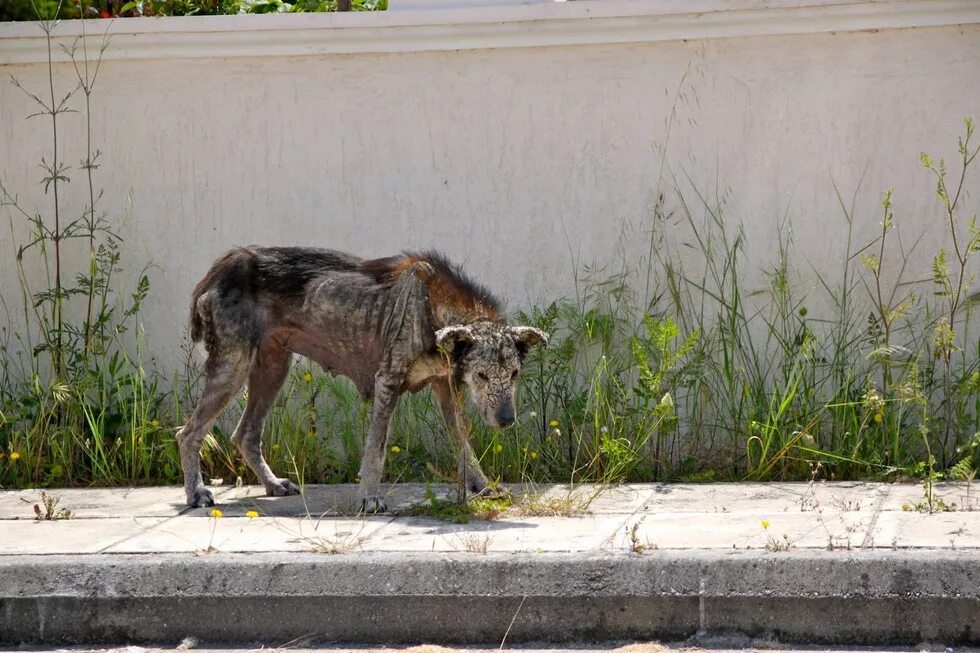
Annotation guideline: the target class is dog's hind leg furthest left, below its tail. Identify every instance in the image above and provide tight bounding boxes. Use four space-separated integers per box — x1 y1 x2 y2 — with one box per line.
177 353 250 508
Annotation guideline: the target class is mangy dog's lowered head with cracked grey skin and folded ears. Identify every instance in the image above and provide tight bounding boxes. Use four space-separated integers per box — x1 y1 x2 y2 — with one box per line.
436 322 548 428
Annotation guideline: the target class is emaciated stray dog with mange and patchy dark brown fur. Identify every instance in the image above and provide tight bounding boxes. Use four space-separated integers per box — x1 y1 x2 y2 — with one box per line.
177 247 548 512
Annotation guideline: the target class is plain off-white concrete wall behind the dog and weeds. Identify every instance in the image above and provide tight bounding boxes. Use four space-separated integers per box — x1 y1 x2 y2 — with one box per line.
0 0 980 372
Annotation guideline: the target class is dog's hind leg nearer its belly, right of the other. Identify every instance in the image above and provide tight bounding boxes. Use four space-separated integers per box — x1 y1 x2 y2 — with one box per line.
231 341 300 497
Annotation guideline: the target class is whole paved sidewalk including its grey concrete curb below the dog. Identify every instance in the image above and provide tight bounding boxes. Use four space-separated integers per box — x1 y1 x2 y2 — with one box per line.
0 483 980 646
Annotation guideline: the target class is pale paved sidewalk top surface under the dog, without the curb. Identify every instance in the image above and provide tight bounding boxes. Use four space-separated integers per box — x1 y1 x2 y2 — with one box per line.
0 483 980 555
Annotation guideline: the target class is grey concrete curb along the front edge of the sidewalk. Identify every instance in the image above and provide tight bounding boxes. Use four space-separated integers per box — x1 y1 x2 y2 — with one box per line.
0 550 980 645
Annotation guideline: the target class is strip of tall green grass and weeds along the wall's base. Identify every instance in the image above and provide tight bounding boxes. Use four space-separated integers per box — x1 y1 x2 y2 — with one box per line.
0 24 980 487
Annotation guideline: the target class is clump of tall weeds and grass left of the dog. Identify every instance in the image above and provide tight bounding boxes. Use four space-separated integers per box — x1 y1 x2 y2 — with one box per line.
0 12 179 492
